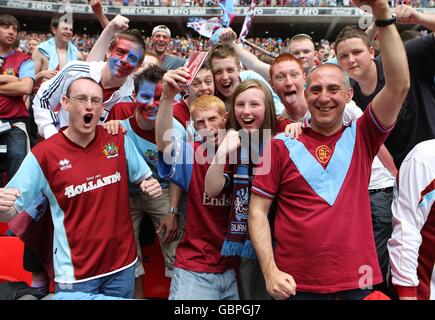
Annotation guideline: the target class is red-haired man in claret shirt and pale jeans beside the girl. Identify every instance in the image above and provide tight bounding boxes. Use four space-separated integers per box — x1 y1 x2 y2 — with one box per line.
156 68 239 300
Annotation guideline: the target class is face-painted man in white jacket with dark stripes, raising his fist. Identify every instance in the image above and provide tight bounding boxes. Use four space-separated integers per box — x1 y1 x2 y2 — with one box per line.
34 15 145 139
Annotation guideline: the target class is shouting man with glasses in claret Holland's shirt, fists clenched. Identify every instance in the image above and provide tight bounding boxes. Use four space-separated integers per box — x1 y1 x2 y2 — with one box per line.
0 78 162 299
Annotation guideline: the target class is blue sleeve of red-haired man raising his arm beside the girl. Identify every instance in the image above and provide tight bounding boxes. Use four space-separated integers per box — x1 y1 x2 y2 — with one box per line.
158 139 194 192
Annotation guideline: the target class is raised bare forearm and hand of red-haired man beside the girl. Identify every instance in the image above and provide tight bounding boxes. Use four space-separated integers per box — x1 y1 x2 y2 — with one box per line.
156 67 190 152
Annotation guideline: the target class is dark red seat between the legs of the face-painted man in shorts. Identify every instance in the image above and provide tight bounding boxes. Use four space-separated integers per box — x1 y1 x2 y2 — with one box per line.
142 237 171 299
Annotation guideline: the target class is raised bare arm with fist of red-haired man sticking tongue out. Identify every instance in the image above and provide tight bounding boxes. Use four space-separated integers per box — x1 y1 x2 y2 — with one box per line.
220 28 270 81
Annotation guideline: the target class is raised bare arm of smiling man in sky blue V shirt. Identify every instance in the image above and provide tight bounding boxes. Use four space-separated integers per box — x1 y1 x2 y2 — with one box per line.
354 0 410 128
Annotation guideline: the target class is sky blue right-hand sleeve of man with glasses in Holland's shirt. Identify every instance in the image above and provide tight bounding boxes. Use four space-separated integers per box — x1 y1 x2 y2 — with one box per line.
124 135 153 183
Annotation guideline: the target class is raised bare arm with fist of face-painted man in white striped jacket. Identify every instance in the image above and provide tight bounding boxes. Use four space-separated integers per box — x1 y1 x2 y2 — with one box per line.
86 14 130 61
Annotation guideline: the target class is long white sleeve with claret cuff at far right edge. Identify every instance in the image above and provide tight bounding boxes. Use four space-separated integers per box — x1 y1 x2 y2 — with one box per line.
388 151 435 296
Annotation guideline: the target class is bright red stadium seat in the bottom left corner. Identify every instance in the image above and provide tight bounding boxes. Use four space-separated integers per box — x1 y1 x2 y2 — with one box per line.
0 236 32 285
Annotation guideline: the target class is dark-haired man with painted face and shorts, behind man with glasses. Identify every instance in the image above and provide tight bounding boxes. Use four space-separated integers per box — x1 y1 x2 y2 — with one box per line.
105 65 185 298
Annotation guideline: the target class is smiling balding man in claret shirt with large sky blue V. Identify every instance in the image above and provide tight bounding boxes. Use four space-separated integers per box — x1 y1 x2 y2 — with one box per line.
248 0 410 300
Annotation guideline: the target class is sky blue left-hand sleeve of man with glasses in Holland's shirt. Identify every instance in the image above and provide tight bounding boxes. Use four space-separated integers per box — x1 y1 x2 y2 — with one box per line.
6 152 49 213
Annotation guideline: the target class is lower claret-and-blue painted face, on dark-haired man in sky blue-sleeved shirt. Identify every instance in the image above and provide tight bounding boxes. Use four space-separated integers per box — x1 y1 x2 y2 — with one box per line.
136 81 162 120
